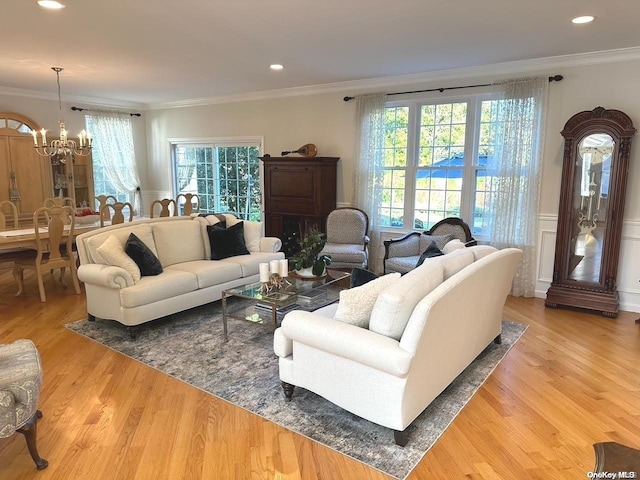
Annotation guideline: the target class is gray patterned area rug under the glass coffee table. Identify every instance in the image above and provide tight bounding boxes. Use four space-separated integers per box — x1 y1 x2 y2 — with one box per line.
66 302 526 479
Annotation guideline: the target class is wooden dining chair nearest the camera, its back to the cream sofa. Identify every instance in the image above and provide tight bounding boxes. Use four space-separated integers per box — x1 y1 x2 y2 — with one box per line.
13 205 80 302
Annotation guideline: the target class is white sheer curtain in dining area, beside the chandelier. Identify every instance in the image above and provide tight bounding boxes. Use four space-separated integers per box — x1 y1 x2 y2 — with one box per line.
86 113 142 213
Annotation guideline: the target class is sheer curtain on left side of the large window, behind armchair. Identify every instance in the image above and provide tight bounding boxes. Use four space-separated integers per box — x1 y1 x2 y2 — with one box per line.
353 93 387 271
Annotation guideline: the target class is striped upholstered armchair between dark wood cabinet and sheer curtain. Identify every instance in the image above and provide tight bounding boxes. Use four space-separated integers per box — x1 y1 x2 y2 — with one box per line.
320 207 369 268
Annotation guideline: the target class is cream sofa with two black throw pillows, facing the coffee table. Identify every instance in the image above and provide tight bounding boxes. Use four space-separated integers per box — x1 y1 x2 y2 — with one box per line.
76 215 284 334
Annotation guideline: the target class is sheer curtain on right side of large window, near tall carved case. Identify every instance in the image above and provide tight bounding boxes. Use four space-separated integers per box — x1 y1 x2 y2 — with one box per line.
487 77 549 297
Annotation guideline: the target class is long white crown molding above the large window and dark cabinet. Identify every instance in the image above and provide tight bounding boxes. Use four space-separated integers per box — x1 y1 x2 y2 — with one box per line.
146 47 640 110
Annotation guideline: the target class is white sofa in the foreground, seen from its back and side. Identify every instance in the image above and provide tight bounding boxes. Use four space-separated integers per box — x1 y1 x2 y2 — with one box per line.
274 245 522 446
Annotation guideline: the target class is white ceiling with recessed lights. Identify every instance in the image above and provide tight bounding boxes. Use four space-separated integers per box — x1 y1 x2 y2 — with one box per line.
0 0 640 106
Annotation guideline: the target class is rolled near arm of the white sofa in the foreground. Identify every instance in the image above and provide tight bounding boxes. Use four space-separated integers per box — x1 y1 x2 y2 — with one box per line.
276 310 413 377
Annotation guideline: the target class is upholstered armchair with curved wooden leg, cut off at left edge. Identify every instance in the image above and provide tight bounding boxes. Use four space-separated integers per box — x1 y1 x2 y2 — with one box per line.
0 339 49 470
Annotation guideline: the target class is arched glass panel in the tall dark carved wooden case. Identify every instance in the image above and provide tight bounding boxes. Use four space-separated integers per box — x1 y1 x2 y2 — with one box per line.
567 133 615 283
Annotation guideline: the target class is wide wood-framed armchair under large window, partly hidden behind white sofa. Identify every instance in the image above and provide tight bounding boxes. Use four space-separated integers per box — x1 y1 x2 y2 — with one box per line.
383 217 478 273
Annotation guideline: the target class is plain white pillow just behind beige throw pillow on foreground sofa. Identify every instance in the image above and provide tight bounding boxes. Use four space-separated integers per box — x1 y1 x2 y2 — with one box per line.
369 255 446 340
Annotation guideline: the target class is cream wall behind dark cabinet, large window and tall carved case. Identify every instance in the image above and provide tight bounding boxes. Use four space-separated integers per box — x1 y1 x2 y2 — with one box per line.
146 60 640 312
